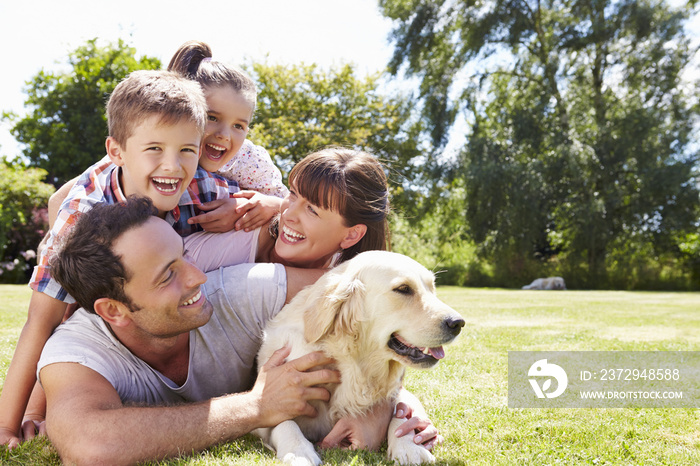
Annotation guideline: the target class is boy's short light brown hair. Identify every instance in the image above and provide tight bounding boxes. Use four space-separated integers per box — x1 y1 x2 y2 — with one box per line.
107 70 207 146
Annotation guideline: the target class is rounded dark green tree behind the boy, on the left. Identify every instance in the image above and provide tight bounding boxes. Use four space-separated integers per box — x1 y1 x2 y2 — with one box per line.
5 39 160 186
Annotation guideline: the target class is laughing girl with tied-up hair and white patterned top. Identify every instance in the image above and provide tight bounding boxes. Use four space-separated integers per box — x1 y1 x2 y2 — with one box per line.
168 41 288 232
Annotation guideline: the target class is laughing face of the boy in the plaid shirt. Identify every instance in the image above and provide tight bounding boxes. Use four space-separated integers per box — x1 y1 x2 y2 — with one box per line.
107 115 201 217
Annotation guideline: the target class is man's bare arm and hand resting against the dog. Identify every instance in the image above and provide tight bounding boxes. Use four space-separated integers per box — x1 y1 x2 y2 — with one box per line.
41 349 340 464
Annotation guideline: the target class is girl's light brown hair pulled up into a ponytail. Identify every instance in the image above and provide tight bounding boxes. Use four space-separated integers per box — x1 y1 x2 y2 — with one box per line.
168 40 258 110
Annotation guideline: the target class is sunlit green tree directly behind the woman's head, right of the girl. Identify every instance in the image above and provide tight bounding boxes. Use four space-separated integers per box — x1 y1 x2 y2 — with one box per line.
248 63 427 218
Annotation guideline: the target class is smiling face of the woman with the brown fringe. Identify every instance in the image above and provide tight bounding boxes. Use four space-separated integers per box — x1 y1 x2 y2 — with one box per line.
275 184 366 268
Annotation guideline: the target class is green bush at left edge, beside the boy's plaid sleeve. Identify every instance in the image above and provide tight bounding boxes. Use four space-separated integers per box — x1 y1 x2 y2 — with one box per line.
0 160 54 283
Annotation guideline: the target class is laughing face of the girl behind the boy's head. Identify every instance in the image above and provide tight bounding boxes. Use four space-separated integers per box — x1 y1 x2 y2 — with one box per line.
199 85 253 172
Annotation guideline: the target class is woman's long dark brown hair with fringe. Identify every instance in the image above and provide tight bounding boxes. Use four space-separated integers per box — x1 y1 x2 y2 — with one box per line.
289 147 390 262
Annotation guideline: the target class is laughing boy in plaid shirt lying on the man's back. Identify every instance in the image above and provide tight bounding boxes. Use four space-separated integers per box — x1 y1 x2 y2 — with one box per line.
0 71 238 448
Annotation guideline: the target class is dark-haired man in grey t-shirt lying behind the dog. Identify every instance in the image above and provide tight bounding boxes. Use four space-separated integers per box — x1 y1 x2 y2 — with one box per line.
38 199 438 464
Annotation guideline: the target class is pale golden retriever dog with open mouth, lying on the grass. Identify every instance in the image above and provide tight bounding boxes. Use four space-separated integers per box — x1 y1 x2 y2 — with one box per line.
255 251 464 465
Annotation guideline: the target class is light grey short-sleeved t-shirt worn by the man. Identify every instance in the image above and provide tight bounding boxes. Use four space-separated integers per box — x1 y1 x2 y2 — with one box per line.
37 263 287 405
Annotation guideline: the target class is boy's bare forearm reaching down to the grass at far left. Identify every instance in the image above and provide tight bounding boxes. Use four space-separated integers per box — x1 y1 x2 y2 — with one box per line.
0 291 66 448
